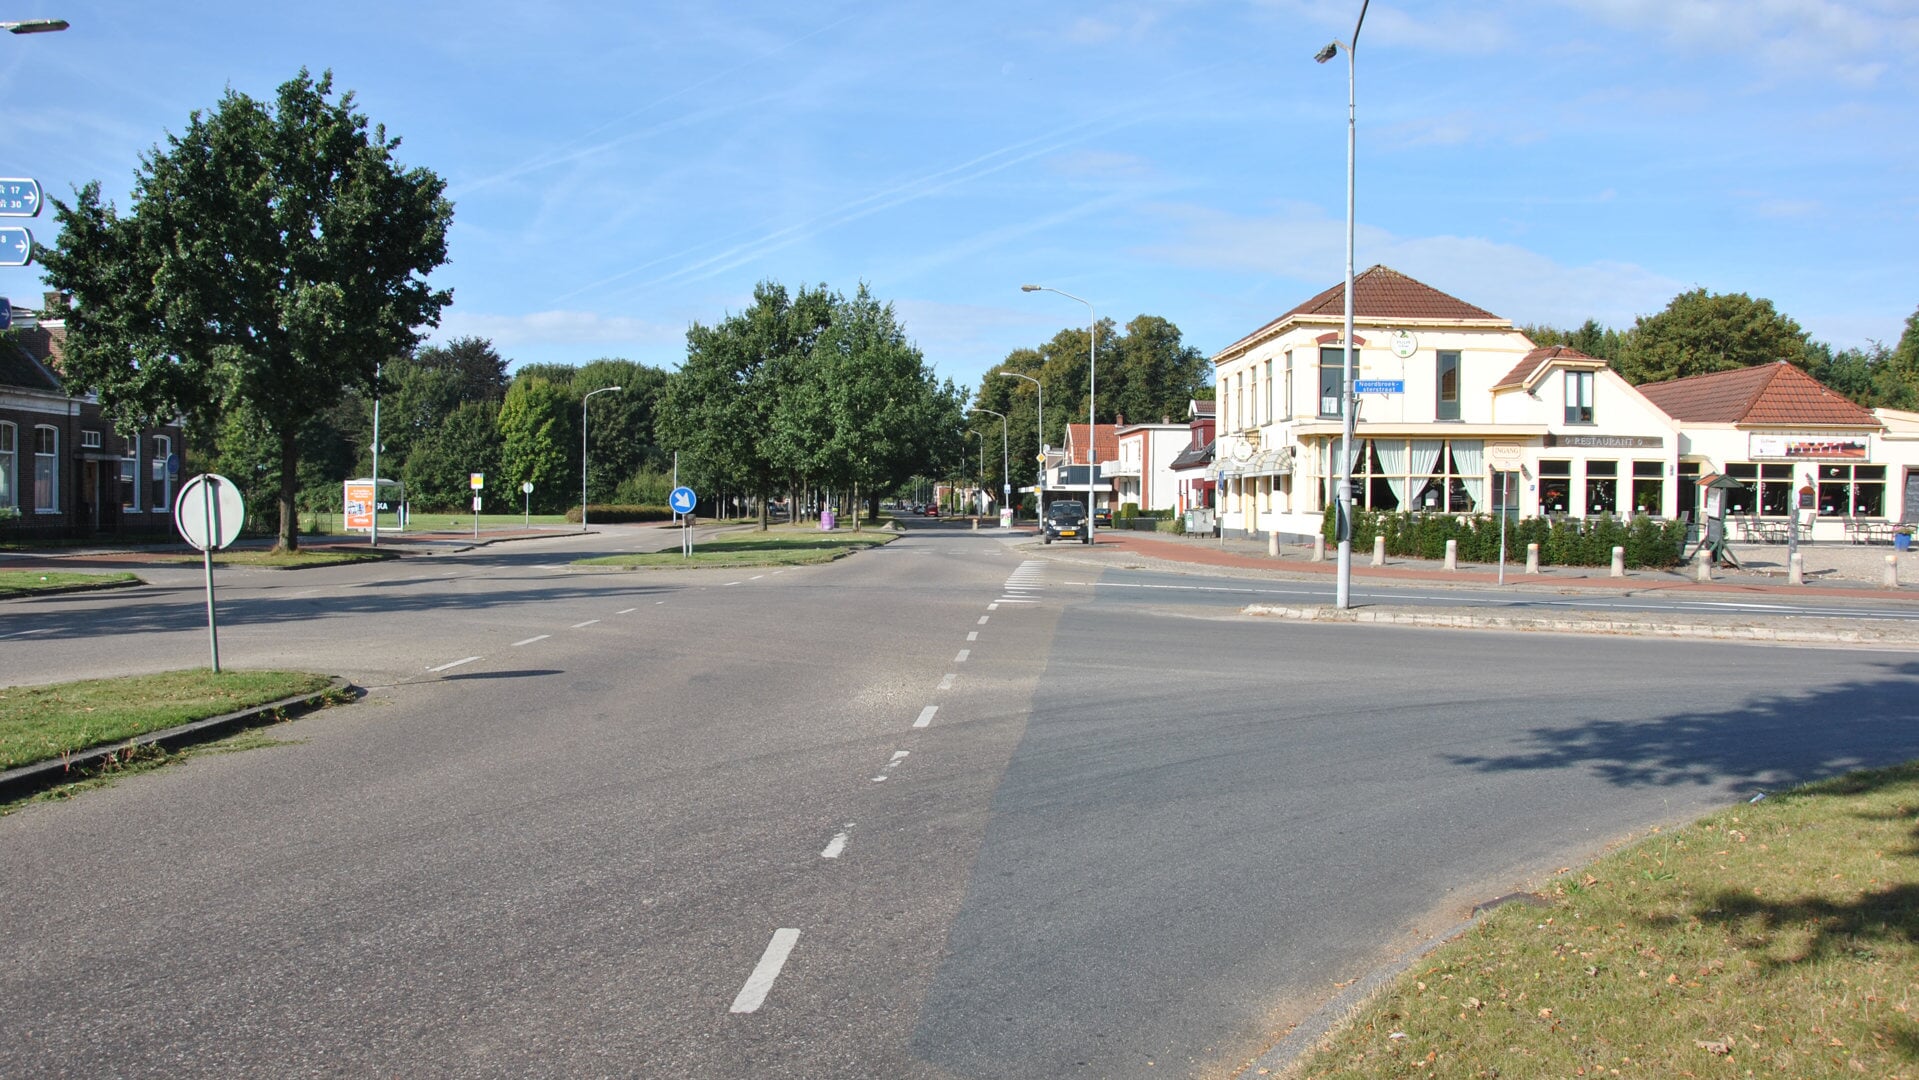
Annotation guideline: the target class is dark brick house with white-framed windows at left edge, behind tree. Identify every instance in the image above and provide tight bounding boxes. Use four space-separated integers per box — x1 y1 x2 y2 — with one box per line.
0 297 186 537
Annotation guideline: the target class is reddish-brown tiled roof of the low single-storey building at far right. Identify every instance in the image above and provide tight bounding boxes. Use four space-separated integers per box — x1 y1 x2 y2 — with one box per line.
1639 361 1881 428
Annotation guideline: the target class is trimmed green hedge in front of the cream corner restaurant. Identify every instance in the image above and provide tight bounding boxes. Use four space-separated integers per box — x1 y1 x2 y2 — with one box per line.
1320 506 1685 570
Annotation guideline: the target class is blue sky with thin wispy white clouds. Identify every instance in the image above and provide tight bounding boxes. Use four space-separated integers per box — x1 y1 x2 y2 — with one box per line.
0 0 1919 395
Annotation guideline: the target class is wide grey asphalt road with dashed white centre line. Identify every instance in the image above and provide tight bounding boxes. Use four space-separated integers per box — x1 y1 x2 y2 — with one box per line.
0 517 1919 1078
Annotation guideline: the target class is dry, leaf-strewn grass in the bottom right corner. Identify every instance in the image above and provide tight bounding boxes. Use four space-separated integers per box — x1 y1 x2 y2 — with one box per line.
1291 762 1919 1078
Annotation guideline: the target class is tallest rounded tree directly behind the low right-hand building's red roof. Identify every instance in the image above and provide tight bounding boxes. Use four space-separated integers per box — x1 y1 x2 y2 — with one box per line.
1620 288 1808 384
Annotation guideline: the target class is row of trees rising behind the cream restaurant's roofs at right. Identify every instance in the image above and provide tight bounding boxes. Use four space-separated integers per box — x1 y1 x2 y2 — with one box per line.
1520 288 1919 409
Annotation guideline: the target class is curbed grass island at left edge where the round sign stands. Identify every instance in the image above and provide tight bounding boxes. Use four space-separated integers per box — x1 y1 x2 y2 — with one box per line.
0 668 330 769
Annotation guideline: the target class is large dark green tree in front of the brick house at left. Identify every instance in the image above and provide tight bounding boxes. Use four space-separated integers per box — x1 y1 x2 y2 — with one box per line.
46 71 453 549
